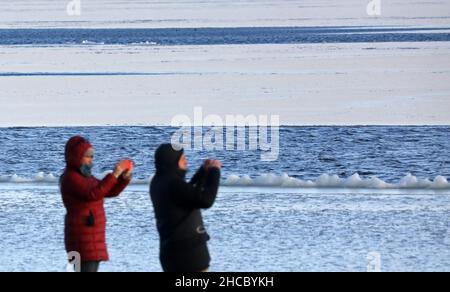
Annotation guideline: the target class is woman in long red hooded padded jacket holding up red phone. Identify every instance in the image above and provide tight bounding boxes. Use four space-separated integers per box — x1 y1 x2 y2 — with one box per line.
60 136 131 272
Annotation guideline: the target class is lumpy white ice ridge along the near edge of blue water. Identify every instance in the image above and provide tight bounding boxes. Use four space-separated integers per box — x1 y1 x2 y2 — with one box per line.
0 172 450 190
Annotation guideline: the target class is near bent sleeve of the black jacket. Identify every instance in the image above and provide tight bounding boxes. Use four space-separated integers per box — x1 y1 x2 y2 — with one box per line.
169 168 220 209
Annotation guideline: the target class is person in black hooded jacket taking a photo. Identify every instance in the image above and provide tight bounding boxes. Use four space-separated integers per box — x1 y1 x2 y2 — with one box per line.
150 144 221 272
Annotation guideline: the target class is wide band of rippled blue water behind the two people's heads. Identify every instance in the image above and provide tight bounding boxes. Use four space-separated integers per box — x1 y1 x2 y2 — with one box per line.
0 126 450 183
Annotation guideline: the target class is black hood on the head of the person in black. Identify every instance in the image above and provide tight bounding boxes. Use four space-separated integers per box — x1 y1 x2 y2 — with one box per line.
155 144 186 176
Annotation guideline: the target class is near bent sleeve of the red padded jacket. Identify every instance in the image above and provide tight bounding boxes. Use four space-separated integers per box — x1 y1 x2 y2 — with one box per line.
65 174 117 201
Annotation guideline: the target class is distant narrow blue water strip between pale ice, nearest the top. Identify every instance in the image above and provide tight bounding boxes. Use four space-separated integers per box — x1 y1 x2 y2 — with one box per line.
0 26 450 45
